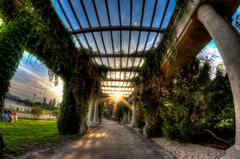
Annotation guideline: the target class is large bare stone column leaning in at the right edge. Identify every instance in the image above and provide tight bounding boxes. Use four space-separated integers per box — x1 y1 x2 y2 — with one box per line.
197 4 240 159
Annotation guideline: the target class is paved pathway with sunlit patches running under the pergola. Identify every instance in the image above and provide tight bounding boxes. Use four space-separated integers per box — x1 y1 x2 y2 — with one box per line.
18 120 175 159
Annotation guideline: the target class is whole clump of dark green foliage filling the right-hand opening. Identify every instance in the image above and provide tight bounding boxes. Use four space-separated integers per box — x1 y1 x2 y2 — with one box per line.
160 59 233 141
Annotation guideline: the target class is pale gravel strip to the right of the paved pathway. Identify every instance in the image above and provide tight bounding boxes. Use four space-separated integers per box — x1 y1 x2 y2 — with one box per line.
153 138 225 159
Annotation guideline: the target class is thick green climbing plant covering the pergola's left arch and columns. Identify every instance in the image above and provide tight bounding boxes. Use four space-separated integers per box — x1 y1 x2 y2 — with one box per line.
0 0 106 134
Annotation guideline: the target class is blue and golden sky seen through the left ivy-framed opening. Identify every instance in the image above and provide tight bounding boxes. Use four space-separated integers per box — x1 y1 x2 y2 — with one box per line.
9 51 62 102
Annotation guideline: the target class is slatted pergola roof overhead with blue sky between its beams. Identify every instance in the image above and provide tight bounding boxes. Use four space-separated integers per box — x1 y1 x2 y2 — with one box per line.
53 0 176 96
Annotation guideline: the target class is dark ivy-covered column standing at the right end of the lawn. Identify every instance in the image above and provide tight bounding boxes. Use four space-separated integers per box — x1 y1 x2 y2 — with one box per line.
57 79 80 134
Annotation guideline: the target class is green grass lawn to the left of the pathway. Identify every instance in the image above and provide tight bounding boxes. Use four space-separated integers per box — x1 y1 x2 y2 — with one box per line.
0 119 77 155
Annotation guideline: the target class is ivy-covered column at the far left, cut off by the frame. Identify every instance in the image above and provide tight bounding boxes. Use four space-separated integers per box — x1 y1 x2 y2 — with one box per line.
0 20 29 113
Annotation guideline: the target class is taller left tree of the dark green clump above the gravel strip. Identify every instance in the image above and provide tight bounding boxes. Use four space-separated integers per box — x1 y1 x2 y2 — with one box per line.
160 59 210 140
